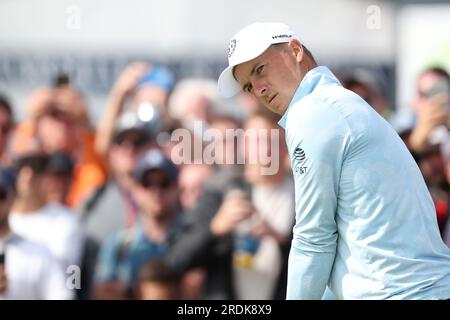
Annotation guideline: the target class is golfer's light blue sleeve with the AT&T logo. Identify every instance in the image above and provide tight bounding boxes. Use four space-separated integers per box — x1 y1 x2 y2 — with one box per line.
286 97 351 300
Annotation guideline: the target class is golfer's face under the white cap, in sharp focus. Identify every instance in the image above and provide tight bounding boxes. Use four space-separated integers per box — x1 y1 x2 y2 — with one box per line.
234 43 303 114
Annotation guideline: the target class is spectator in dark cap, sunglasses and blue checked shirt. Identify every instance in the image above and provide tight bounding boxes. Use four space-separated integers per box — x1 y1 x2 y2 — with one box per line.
95 149 181 299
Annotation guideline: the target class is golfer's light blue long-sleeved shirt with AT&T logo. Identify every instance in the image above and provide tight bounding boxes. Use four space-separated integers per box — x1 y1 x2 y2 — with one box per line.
279 66 450 299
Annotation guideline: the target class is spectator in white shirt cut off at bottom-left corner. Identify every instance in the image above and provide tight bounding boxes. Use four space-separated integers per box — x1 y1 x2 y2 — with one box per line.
0 167 74 300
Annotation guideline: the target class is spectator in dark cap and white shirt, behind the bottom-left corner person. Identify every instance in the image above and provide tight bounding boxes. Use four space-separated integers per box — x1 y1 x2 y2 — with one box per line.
9 150 84 268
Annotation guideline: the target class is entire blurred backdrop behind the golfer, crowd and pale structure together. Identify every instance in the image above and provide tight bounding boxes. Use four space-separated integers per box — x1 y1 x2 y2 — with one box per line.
0 0 450 299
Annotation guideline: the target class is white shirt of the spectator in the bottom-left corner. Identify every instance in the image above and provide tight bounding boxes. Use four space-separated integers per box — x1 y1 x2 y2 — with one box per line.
0 233 74 300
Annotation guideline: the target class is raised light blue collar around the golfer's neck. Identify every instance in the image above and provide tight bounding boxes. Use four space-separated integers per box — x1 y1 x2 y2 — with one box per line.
278 66 340 128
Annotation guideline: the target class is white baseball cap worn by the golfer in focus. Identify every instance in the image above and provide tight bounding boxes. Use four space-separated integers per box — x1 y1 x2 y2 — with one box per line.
218 22 300 98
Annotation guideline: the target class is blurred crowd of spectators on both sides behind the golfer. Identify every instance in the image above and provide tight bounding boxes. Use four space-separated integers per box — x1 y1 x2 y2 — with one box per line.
0 62 450 300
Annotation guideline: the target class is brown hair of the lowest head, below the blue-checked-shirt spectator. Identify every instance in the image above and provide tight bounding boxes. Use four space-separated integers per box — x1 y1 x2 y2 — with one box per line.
138 259 181 286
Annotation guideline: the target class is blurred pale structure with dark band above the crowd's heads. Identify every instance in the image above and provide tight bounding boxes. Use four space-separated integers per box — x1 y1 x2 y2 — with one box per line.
0 0 450 119
